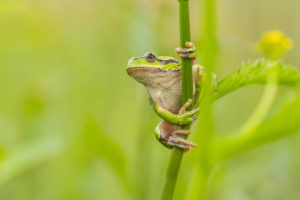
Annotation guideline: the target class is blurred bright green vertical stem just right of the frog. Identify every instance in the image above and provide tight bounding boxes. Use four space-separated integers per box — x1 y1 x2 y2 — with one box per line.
191 0 217 200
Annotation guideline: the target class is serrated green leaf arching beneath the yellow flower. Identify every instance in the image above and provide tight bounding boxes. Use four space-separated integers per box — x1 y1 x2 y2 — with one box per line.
212 59 300 101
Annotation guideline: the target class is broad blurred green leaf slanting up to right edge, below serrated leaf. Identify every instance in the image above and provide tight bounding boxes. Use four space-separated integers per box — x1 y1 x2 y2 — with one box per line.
215 90 300 161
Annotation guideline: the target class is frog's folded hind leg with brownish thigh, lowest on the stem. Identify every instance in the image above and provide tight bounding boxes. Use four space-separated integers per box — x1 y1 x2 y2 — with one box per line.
155 121 196 151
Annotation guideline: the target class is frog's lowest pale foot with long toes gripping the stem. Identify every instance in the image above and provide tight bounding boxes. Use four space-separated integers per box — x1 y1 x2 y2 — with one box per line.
168 130 197 152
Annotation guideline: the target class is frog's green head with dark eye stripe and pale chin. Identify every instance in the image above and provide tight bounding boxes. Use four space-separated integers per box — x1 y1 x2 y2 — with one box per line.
126 52 180 85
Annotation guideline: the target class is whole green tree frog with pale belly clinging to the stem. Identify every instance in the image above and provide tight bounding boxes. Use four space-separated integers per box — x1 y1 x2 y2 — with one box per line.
126 42 204 152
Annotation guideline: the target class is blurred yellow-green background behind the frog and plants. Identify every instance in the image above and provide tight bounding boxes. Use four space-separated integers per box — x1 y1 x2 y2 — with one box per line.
0 0 300 200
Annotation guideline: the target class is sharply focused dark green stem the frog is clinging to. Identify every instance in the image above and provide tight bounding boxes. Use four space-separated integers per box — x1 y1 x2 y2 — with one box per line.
161 0 193 200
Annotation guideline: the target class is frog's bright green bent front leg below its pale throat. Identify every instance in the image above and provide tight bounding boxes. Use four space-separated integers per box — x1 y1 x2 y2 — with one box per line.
150 98 199 125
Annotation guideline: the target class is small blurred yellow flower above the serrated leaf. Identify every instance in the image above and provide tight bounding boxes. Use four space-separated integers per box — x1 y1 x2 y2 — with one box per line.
258 30 293 60
